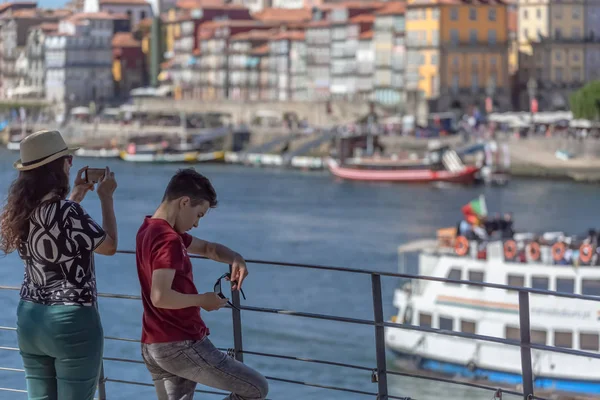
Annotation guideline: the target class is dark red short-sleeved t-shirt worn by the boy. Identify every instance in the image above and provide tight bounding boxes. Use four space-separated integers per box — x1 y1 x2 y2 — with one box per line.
135 217 209 343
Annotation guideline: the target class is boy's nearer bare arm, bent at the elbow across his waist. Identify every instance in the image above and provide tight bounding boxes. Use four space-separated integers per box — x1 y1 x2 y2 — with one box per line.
150 268 227 311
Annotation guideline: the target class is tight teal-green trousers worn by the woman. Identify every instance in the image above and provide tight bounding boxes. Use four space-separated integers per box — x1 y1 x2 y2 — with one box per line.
17 301 104 400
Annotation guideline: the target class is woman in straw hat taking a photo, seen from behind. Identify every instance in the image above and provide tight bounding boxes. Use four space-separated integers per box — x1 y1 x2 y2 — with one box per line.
0 131 117 400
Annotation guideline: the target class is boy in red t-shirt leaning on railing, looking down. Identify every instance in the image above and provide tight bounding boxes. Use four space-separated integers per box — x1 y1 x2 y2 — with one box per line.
136 169 268 400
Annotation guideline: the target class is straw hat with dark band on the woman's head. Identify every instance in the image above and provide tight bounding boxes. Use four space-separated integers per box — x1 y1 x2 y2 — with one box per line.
14 130 78 171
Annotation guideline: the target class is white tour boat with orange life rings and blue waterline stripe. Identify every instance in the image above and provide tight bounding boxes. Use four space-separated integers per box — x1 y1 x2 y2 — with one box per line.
385 228 600 395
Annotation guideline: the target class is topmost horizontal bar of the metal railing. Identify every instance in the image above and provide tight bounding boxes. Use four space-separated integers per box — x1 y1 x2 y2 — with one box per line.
115 250 600 302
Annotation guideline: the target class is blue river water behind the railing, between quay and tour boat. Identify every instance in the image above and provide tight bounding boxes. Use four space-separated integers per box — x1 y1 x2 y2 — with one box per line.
0 149 600 400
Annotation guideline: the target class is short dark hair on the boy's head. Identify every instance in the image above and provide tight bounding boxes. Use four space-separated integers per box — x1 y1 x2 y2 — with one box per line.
162 168 218 208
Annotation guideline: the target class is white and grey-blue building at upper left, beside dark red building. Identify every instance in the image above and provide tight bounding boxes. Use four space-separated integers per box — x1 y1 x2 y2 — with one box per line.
45 12 122 104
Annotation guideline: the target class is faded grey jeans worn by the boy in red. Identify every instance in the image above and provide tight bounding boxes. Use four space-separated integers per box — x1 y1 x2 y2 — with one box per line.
142 337 269 400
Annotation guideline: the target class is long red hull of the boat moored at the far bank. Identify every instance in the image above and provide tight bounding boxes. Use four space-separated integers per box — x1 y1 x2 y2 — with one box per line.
327 159 478 184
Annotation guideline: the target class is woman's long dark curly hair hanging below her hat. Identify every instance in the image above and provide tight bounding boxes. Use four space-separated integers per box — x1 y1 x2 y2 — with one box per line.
0 157 70 254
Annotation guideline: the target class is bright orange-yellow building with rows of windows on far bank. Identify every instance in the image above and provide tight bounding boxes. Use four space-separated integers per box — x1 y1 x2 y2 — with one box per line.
406 0 510 111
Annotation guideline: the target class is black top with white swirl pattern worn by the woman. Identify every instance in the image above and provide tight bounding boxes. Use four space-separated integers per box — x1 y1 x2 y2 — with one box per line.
19 200 106 306
